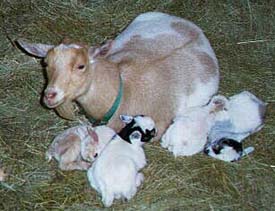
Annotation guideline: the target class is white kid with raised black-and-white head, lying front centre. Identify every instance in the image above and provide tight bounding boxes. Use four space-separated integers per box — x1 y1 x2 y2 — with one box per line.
88 116 156 207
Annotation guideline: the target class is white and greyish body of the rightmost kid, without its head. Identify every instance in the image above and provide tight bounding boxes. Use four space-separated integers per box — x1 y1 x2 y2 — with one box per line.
208 91 266 143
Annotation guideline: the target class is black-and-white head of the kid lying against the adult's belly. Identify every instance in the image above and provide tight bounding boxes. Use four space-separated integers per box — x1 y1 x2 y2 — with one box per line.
118 115 157 143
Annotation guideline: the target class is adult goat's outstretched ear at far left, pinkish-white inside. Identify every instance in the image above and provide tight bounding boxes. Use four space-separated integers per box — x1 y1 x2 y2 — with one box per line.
16 39 54 58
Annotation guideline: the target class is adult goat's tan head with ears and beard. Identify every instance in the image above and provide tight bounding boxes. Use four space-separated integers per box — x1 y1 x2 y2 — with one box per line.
17 40 112 119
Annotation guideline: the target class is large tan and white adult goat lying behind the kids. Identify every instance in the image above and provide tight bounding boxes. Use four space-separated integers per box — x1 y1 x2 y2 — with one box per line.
18 12 219 138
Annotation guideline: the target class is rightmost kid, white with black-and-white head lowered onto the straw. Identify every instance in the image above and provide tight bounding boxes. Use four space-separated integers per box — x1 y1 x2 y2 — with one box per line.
204 91 266 162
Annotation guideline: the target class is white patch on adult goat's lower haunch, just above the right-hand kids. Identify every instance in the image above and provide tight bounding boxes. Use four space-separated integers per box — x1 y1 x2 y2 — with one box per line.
176 79 219 116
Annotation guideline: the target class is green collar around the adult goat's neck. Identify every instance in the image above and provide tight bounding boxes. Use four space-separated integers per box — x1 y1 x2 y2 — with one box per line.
81 74 123 126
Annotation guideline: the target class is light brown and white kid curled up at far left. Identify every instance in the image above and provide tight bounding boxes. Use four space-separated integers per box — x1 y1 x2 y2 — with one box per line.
46 125 115 170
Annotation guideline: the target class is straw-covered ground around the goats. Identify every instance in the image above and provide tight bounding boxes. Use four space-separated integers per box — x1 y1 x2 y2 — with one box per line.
0 0 275 210
